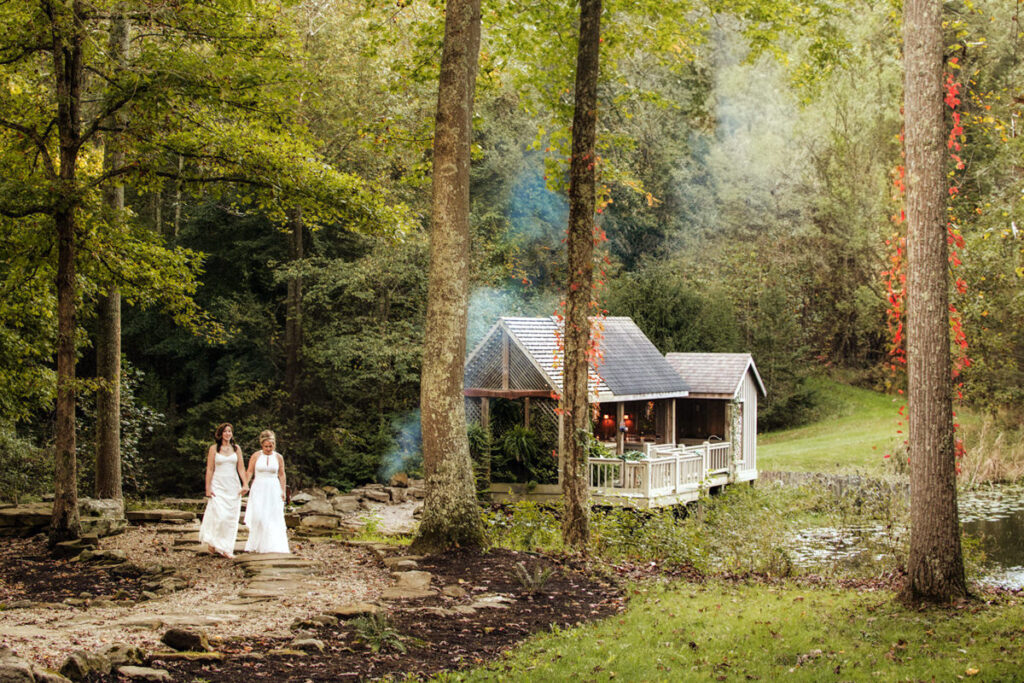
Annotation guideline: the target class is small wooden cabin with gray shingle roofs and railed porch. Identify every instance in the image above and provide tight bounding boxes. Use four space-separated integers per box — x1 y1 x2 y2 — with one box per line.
464 317 764 507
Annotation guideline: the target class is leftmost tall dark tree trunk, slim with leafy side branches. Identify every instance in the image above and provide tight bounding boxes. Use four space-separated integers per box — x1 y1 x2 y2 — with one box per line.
49 0 84 545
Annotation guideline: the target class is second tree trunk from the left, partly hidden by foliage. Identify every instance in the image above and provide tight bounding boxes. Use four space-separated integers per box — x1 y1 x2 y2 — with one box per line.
95 13 128 499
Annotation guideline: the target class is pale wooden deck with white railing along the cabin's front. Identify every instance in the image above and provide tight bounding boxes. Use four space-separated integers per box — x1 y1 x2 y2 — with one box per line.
490 441 758 508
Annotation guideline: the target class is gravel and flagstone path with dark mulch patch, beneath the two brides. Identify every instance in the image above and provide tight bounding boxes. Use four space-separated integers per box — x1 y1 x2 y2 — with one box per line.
0 522 393 668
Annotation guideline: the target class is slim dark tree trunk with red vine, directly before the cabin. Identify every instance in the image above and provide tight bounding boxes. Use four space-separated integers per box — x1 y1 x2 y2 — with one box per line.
562 0 601 552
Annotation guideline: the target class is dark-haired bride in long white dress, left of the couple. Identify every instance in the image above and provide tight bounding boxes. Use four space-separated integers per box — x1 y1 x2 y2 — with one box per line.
199 422 249 557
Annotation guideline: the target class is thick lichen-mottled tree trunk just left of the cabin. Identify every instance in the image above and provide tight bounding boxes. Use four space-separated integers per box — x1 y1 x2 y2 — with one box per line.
414 0 483 552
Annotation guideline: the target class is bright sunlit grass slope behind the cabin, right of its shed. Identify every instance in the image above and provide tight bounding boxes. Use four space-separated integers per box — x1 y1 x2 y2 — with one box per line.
758 379 906 475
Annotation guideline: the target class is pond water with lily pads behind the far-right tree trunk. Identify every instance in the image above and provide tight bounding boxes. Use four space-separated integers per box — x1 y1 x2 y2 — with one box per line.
790 485 1024 589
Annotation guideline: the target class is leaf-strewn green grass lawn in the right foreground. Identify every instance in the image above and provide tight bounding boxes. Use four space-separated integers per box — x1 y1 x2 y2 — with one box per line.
437 581 1024 682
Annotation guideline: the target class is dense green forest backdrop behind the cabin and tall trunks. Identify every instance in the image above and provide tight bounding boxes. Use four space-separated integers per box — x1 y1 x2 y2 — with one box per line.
0 0 1024 495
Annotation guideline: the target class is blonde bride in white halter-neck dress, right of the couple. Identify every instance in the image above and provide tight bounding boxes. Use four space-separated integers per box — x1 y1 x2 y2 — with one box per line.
240 429 292 553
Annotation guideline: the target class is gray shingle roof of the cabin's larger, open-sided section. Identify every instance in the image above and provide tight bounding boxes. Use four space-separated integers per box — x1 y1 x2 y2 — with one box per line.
469 317 686 400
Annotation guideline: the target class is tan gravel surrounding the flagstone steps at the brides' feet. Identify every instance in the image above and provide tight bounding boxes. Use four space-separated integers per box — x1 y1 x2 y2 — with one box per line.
0 525 393 669
